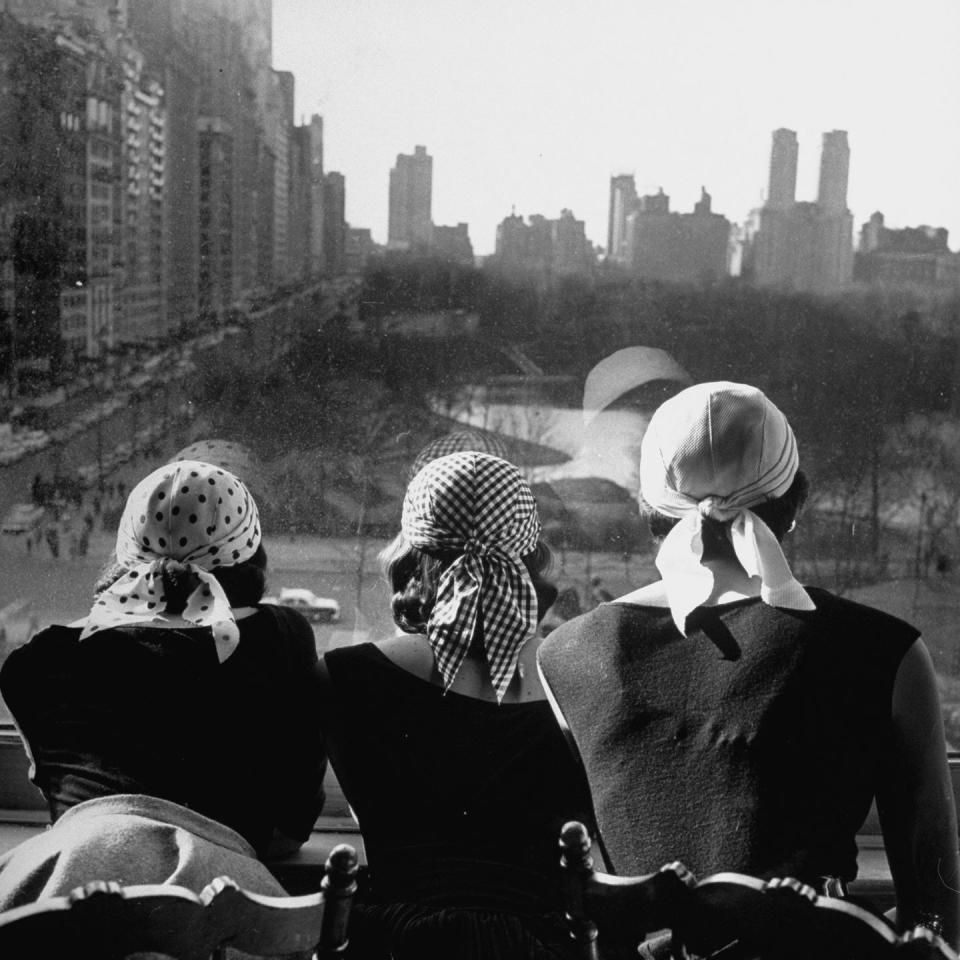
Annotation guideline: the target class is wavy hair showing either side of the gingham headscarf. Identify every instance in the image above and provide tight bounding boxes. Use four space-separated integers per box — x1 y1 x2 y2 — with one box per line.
380 533 556 633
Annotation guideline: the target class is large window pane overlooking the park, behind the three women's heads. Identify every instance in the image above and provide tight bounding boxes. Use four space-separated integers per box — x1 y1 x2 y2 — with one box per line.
0 0 960 772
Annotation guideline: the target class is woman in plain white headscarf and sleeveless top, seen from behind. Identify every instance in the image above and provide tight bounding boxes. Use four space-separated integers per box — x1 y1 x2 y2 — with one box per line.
539 382 958 945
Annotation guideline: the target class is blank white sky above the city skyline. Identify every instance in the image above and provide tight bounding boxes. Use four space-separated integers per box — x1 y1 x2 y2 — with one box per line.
273 0 960 254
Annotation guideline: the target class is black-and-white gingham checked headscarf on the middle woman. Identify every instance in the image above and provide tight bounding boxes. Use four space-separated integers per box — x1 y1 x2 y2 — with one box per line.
402 453 540 703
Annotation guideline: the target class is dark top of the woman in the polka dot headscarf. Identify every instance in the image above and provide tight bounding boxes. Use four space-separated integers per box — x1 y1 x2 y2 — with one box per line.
0 605 326 852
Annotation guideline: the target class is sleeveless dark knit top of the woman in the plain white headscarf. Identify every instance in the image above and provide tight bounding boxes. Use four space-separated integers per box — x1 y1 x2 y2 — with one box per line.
539 588 918 880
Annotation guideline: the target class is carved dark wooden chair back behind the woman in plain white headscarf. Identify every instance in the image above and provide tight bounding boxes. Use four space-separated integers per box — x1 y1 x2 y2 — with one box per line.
560 822 958 960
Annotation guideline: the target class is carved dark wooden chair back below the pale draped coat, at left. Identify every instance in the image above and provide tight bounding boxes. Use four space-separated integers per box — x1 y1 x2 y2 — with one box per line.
0 844 357 960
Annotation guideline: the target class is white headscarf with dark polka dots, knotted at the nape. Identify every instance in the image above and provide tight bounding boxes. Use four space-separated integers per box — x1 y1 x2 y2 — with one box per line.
80 460 260 663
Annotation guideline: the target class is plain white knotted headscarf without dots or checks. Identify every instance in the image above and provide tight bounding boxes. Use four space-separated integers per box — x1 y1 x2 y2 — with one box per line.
640 381 815 634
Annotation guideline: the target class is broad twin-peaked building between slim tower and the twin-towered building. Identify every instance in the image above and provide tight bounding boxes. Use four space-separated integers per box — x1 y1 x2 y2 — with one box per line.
623 188 730 283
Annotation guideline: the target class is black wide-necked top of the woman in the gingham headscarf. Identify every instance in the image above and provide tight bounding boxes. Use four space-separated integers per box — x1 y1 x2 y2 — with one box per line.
321 643 589 911
